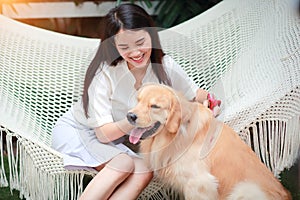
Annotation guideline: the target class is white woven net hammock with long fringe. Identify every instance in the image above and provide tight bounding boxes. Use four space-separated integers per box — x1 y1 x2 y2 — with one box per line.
0 0 300 200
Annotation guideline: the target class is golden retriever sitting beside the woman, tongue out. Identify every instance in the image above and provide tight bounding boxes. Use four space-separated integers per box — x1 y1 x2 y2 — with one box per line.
127 84 291 200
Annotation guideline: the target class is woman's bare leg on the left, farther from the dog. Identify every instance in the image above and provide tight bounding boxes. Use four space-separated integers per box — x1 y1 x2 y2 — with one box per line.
80 154 135 200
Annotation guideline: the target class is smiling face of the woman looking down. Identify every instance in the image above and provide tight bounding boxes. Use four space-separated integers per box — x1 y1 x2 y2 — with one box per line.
115 29 152 70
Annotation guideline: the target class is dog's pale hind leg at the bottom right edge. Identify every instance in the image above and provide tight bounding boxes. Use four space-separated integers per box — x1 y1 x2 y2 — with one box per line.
227 182 268 200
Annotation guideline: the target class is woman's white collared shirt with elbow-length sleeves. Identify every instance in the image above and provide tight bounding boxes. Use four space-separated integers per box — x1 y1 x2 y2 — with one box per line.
71 55 198 128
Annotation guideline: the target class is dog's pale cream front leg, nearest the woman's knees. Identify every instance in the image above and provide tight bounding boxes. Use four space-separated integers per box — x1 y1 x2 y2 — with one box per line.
182 172 218 200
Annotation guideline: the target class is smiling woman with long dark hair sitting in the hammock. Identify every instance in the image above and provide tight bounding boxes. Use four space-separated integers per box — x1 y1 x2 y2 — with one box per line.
52 4 216 200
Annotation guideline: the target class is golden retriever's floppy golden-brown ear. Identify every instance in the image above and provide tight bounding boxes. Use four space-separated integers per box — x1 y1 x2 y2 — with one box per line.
165 98 182 133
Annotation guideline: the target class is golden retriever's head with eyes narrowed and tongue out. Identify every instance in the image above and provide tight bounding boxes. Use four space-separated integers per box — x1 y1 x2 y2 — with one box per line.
127 84 182 144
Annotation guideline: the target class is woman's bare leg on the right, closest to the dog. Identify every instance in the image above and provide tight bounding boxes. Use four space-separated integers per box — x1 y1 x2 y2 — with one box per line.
109 158 153 200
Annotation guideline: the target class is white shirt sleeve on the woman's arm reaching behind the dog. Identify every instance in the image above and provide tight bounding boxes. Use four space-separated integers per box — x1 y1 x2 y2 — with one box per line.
163 55 199 100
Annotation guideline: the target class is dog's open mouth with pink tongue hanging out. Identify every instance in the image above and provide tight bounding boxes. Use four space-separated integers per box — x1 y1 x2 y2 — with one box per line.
129 121 161 144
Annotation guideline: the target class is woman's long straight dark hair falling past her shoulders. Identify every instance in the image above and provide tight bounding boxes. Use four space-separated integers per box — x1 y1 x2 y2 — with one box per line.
82 4 171 117
